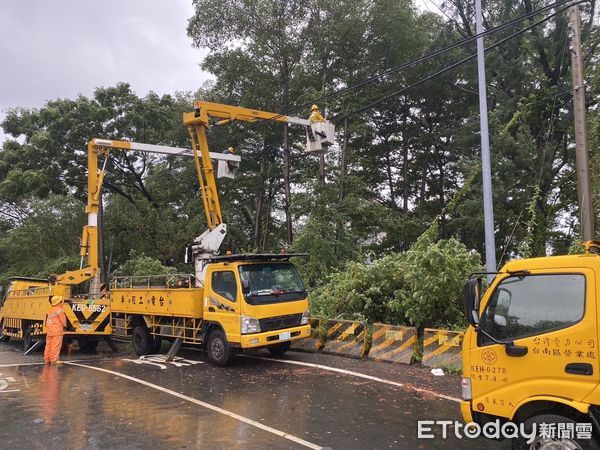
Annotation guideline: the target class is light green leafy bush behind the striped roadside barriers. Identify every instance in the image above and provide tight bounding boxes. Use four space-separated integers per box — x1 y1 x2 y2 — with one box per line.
311 232 480 327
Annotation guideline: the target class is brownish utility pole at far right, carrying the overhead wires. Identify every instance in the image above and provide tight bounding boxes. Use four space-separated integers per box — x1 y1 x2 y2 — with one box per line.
569 6 596 241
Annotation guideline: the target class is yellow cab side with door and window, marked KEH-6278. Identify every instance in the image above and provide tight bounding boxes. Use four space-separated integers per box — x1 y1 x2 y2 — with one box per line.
470 268 600 417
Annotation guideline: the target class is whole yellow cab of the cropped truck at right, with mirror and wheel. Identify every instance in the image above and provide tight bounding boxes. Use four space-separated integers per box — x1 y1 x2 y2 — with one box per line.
461 244 600 448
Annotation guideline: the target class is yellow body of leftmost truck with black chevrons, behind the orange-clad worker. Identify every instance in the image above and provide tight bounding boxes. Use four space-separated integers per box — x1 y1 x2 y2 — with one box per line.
0 277 112 350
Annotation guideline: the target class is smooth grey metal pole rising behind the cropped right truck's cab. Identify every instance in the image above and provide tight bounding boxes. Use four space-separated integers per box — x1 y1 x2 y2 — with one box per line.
475 0 496 282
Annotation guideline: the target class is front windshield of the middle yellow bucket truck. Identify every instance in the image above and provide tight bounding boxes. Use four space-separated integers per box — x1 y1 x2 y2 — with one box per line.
239 263 306 305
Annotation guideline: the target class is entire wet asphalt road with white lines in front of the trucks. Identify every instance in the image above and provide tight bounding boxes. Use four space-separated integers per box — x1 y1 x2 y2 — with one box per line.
0 343 506 449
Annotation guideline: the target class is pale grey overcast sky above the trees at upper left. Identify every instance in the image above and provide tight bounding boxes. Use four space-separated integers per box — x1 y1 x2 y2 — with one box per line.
0 0 210 140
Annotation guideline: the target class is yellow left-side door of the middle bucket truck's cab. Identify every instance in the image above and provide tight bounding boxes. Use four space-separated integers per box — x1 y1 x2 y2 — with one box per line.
204 270 240 343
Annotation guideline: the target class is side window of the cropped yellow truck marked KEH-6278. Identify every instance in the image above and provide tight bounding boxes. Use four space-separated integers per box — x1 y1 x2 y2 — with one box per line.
480 274 585 344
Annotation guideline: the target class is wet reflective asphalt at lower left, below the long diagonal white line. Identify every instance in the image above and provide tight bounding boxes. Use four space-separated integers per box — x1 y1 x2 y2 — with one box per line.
0 360 286 449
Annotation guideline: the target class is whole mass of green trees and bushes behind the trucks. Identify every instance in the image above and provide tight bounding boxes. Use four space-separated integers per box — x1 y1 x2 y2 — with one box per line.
0 0 600 326
